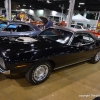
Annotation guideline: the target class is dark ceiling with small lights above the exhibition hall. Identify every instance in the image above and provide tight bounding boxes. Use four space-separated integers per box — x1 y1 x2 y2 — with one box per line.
0 0 100 13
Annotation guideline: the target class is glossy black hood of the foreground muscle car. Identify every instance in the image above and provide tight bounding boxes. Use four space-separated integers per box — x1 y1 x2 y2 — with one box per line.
0 37 60 57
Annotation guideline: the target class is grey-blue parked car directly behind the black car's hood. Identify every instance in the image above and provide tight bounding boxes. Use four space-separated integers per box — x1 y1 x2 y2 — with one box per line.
0 21 42 37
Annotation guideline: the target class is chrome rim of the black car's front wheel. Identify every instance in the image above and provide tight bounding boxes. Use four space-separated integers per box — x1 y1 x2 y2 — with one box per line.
32 65 48 81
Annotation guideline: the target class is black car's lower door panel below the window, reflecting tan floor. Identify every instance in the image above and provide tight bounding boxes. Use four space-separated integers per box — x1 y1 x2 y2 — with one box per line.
66 43 95 64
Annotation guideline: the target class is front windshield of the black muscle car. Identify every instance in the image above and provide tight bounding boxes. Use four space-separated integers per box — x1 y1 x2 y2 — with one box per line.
39 28 73 44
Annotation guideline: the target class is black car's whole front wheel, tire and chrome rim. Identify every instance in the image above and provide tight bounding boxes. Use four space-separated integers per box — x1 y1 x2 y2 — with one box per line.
26 62 52 84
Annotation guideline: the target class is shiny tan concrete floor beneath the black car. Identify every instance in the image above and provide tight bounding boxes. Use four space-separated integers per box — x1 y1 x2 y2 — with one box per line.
0 62 100 100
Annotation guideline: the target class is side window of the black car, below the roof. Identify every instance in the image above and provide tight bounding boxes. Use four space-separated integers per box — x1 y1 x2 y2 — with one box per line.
71 33 94 45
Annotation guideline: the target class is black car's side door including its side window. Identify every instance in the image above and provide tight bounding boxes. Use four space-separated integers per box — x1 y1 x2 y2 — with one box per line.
66 33 96 64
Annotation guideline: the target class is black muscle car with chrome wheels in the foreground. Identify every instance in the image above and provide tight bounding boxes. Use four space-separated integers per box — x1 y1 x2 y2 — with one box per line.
0 27 100 84
